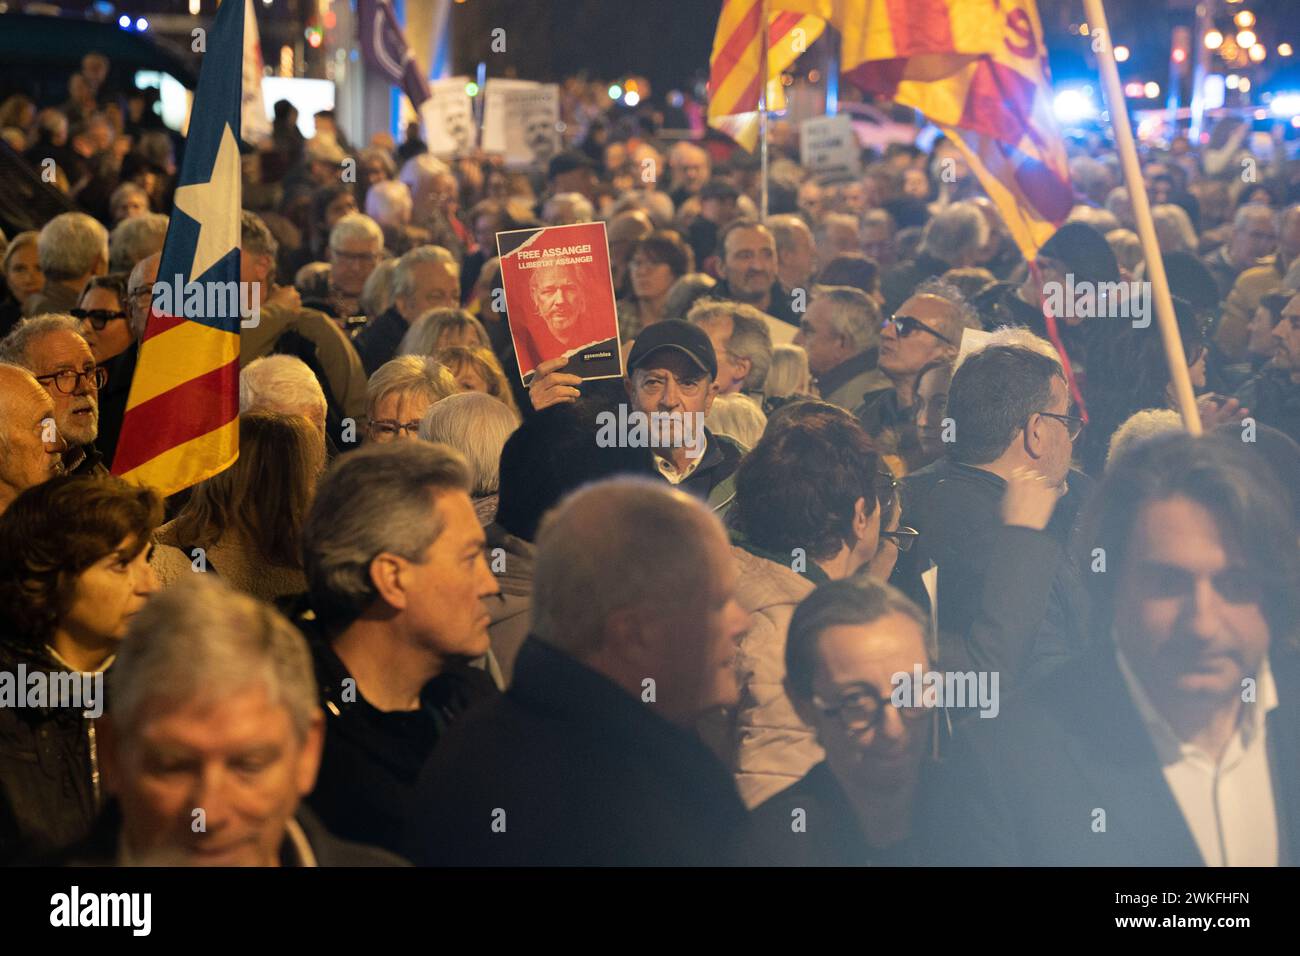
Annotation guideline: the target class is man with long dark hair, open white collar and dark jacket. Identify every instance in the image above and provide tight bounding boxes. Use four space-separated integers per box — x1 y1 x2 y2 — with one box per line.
923 433 1300 866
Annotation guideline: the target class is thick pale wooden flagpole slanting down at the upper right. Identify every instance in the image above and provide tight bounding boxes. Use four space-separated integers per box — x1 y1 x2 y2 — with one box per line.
1083 0 1201 434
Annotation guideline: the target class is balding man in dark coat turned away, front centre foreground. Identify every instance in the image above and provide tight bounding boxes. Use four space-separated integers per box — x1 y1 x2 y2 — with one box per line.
408 479 748 866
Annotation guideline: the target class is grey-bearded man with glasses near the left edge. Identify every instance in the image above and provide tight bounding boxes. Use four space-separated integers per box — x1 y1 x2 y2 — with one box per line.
0 313 108 475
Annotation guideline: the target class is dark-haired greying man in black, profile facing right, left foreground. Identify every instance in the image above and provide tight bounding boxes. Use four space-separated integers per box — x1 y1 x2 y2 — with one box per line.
303 442 498 851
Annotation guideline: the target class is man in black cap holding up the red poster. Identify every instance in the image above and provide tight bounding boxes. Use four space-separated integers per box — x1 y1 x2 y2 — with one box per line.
625 320 745 505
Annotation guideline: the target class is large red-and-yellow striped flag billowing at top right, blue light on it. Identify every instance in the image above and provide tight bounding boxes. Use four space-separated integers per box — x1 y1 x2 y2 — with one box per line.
771 0 1074 260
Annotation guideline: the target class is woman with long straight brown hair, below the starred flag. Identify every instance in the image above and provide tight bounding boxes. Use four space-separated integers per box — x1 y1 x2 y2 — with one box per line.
153 411 325 601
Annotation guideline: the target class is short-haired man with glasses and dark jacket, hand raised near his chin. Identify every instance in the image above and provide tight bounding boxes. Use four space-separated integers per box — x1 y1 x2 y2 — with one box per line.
894 346 1087 691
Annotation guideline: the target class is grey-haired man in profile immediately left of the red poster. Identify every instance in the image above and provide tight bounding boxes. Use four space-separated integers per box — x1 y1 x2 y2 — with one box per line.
352 246 460 375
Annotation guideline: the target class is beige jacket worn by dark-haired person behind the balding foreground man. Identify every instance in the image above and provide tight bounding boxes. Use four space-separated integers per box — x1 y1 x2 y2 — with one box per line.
732 546 824 808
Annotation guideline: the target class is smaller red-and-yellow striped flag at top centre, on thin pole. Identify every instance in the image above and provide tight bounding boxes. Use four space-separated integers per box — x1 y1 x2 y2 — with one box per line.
709 0 826 151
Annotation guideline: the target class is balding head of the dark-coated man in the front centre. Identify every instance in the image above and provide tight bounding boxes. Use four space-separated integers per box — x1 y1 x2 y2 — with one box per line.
533 479 749 722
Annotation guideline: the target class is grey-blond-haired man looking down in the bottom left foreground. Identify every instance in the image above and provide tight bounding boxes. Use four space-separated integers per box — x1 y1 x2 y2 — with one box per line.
49 575 402 866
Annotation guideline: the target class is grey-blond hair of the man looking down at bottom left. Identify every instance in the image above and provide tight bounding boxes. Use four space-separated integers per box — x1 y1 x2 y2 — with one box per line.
109 575 321 740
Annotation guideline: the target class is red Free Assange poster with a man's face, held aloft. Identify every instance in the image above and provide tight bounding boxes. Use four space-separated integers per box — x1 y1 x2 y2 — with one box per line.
497 222 623 385
